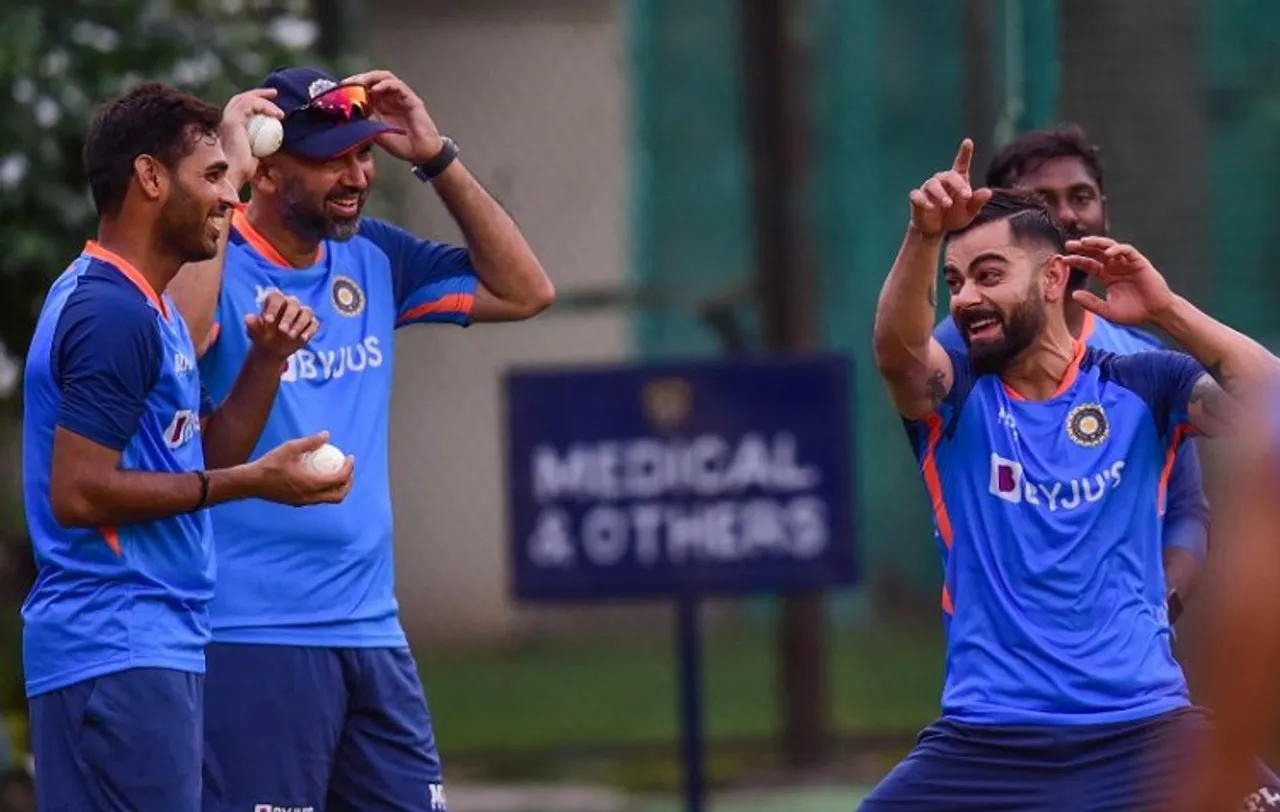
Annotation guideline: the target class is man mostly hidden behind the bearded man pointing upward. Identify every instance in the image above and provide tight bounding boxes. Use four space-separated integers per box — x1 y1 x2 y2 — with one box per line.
933 124 1208 622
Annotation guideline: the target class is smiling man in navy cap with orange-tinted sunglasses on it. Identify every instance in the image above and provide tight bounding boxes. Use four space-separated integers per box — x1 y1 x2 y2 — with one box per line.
167 68 553 812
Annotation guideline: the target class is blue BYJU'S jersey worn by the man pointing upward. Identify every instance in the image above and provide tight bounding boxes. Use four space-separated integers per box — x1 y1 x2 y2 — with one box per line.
906 343 1203 725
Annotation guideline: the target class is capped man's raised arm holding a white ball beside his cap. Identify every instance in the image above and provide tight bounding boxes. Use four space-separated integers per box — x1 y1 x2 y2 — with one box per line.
165 88 284 356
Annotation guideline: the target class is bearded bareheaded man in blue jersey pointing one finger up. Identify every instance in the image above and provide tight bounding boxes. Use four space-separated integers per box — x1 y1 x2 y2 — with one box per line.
863 140 1280 811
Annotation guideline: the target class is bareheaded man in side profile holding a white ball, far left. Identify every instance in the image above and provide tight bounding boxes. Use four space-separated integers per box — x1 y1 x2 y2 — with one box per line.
23 83 352 812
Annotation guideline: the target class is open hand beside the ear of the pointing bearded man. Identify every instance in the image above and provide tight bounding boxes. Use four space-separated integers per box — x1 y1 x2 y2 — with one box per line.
1065 237 1174 324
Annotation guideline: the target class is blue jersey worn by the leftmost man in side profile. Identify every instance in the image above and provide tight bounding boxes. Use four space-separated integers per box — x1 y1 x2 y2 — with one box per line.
22 242 214 697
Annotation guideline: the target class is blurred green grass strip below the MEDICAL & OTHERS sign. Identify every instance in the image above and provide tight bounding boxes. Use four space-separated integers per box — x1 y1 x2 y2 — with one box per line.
417 619 942 754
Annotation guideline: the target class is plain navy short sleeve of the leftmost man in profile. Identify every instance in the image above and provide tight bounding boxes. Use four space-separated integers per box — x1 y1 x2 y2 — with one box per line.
51 287 164 451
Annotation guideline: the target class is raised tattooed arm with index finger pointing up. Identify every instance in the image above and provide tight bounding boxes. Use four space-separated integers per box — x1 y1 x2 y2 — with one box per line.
874 138 991 420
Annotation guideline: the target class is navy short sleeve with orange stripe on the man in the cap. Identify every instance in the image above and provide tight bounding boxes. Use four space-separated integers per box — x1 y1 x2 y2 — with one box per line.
361 220 479 327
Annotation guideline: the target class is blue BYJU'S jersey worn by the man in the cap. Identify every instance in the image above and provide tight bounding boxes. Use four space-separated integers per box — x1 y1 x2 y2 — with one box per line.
201 211 476 647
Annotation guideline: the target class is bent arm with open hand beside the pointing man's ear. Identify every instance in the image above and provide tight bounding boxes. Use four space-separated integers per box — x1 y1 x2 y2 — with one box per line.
1066 237 1280 437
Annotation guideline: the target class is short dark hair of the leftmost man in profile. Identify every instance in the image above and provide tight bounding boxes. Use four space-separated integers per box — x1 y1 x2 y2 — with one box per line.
83 82 223 218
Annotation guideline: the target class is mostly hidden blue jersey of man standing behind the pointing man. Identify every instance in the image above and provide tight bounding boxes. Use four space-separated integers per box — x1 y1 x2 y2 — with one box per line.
933 311 1208 562
